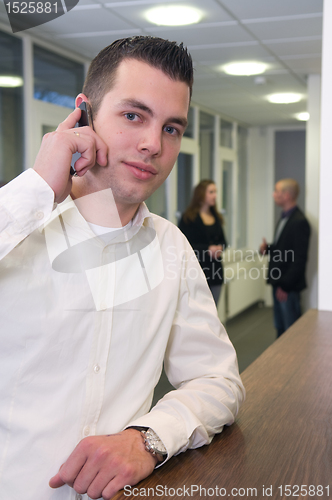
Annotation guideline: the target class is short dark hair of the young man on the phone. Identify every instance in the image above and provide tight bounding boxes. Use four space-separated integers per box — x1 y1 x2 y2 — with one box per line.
83 36 194 114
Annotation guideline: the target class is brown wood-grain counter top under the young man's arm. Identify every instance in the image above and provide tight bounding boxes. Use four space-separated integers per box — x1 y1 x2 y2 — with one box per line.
116 310 332 500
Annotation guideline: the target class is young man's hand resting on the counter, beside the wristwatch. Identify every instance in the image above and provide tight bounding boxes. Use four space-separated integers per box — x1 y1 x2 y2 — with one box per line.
49 429 157 500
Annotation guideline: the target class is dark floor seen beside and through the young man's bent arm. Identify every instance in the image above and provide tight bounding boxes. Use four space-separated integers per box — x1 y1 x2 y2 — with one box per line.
153 298 276 404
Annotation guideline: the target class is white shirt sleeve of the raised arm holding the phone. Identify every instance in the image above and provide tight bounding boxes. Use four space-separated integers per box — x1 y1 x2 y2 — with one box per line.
0 169 54 259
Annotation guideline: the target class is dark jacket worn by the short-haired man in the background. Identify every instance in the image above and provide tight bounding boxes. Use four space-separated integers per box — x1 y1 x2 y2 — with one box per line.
268 207 310 292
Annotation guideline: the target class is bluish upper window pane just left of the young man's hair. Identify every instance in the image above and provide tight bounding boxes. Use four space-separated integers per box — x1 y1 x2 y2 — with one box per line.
33 45 84 108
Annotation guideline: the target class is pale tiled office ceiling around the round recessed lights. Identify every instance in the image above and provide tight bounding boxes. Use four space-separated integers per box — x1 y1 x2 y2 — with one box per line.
0 0 323 126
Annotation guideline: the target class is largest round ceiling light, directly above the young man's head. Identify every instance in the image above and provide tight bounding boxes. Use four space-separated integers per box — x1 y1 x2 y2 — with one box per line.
145 5 203 26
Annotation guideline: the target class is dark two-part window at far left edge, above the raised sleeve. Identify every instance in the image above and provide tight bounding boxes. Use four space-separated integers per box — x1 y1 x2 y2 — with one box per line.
0 32 24 185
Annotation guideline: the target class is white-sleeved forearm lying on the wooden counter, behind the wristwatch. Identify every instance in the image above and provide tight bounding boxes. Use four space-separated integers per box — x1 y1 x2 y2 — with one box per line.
126 377 244 459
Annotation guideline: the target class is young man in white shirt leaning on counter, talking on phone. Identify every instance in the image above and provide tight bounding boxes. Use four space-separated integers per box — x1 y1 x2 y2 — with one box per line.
0 37 244 500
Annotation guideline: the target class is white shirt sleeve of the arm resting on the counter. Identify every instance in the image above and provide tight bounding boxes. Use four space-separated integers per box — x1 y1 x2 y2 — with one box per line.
126 236 245 458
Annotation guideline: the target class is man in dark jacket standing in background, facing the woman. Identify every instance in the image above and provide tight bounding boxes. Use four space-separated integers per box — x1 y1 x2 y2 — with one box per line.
260 179 310 337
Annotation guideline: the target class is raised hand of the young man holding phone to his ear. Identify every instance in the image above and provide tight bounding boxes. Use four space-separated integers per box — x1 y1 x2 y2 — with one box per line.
33 108 107 203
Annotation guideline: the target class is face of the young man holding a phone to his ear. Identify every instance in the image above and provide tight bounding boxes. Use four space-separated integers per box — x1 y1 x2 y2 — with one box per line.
90 59 189 209
